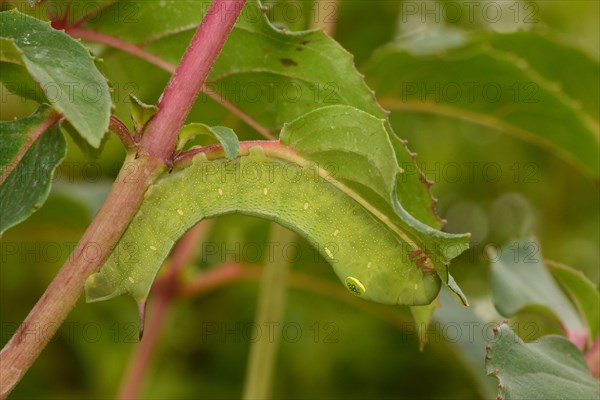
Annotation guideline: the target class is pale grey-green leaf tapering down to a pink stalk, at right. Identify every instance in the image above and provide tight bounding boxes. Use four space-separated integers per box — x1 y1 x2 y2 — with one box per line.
489 238 586 339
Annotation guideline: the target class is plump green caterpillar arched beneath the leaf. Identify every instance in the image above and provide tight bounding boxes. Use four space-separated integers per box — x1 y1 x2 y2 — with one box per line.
86 146 441 305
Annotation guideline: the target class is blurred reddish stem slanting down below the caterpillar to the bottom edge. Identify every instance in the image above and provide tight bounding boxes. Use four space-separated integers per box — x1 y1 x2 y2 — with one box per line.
117 222 206 399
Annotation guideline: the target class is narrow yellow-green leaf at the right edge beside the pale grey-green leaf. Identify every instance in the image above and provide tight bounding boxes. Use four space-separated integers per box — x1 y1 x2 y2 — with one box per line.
546 261 600 345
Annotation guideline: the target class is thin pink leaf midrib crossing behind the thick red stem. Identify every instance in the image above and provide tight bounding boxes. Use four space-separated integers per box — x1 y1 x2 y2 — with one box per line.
65 26 275 139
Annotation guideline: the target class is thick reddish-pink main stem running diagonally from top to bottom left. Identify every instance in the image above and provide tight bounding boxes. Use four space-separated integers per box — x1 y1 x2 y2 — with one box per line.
0 0 245 398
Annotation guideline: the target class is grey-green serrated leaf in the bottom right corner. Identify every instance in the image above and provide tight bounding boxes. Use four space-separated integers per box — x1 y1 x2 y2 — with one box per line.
486 324 600 400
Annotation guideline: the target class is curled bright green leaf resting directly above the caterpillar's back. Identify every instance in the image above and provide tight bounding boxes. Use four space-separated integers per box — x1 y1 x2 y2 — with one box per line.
280 105 469 304
